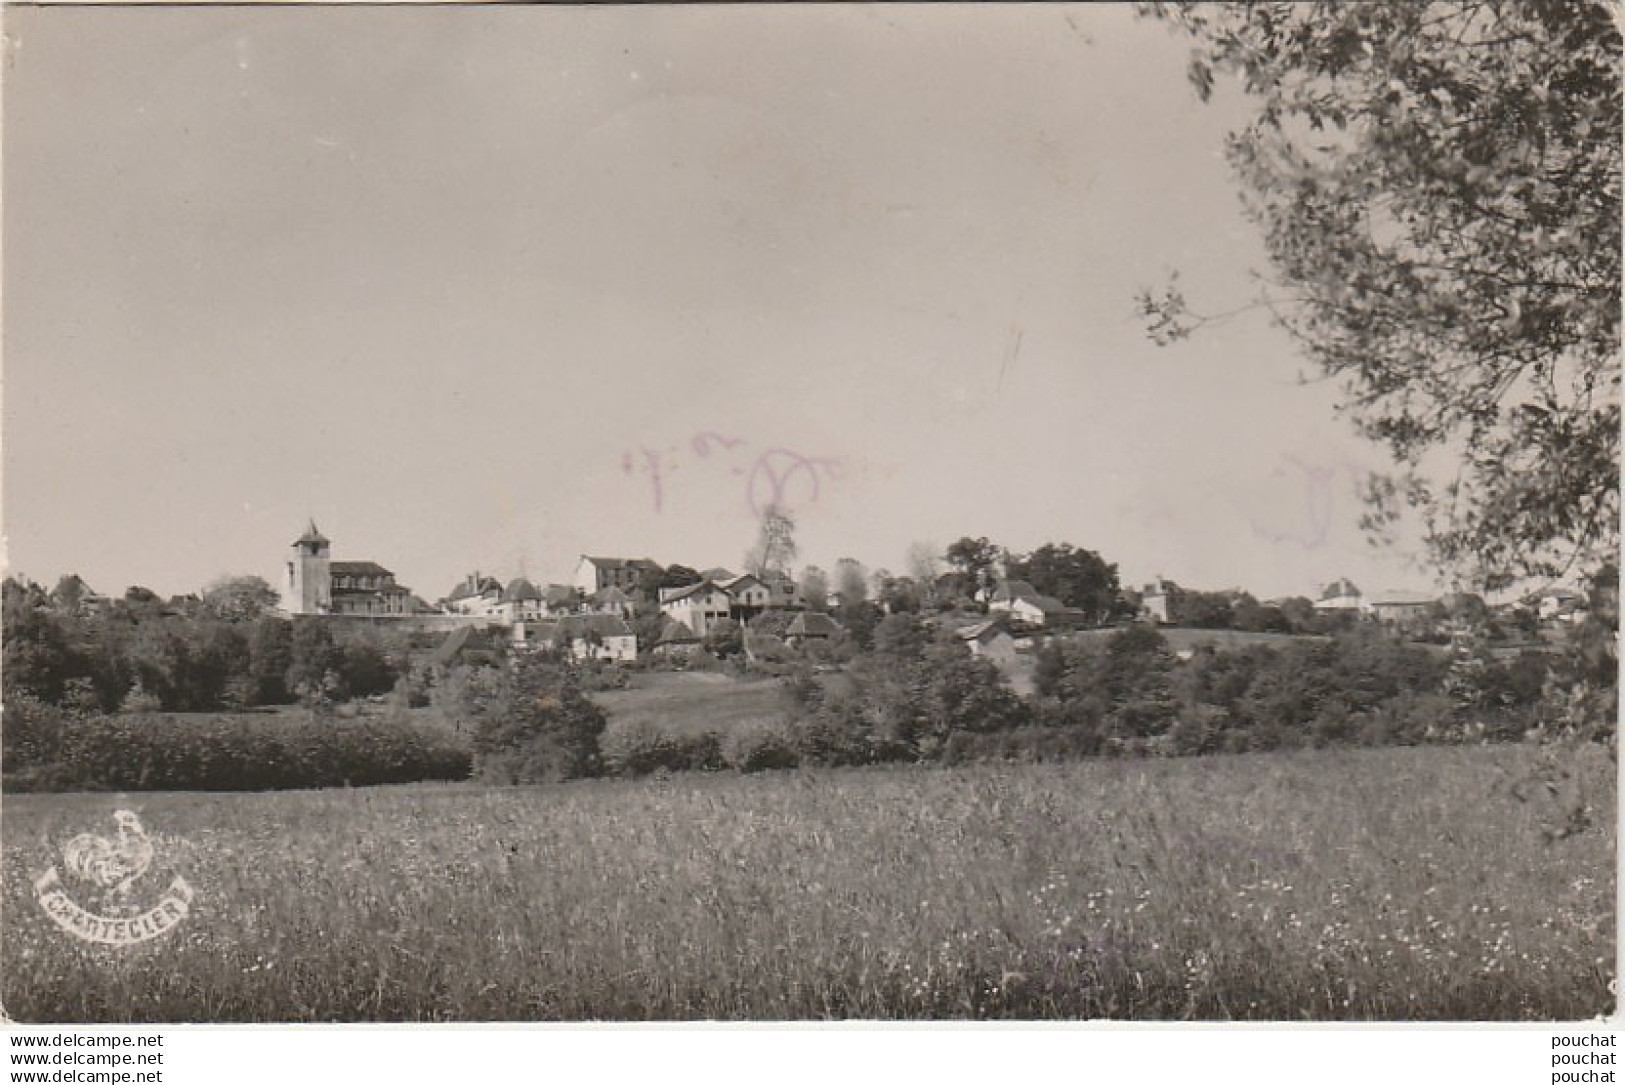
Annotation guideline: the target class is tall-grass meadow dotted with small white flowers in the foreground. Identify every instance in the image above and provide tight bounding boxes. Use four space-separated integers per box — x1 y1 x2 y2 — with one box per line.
0 747 1615 1022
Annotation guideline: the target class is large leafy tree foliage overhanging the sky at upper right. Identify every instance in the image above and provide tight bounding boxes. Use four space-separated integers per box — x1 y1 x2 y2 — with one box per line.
1139 0 1622 590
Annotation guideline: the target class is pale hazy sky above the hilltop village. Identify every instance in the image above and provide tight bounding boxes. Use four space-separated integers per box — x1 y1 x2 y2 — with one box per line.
3 5 1432 599
